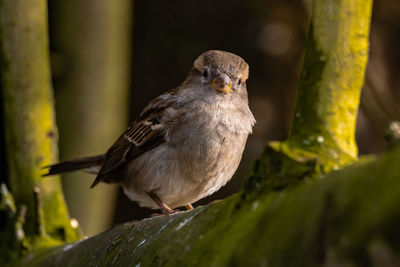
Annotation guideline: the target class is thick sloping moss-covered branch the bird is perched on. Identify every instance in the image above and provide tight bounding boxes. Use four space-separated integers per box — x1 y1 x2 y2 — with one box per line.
22 149 400 266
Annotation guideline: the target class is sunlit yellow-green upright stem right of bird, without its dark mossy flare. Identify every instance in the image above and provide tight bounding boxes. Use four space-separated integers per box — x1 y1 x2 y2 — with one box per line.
287 0 372 171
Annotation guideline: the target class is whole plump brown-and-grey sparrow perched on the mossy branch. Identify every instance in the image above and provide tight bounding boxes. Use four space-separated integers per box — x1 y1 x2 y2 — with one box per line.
43 50 256 214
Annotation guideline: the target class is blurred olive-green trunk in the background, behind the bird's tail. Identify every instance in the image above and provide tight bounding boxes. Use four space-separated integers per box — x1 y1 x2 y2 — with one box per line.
53 0 132 235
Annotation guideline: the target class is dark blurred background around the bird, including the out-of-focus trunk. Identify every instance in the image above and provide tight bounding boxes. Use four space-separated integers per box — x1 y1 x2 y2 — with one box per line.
36 0 400 235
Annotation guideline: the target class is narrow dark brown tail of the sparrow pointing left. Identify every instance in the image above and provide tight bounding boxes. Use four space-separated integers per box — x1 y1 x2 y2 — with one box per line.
43 155 105 176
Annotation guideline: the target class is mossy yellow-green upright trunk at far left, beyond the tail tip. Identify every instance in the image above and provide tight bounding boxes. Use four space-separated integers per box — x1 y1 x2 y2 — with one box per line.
0 0 78 262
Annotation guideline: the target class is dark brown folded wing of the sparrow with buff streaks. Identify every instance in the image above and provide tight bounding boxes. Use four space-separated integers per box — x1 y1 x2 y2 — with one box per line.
91 92 176 187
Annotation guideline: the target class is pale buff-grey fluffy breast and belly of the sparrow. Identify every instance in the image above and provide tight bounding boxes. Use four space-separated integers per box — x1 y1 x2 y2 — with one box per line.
125 100 251 207
